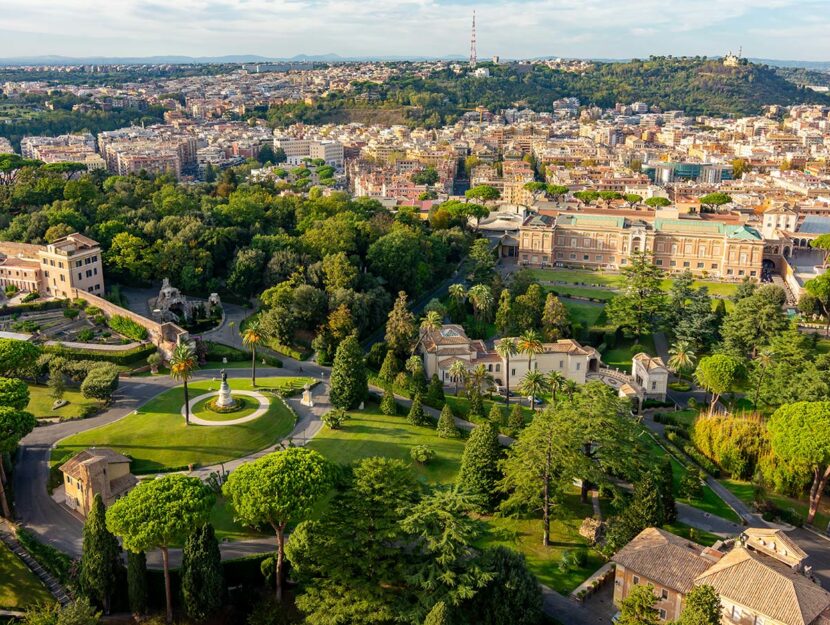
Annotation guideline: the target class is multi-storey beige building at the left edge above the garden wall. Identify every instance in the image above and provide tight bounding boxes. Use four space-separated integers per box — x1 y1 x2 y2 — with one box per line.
0 233 104 298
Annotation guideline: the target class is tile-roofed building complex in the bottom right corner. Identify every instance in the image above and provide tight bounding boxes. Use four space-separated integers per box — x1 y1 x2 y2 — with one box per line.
613 528 830 625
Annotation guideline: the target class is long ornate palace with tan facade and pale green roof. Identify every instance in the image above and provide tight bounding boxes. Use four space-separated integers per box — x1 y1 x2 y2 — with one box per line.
519 211 764 280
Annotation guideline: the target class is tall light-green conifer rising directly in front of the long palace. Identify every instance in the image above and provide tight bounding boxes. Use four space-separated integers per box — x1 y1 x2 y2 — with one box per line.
605 252 665 340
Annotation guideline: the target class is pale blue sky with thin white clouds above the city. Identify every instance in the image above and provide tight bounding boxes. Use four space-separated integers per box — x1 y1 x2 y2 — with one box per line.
0 0 830 61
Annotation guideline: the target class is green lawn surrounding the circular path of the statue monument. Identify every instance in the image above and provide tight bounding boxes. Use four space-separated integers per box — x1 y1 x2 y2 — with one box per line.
51 378 313 474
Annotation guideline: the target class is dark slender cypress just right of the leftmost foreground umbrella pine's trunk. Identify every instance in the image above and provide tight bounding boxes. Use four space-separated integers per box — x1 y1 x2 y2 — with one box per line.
181 523 224 621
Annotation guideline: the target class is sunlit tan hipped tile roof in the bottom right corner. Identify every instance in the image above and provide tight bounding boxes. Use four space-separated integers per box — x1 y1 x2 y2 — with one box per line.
695 545 830 625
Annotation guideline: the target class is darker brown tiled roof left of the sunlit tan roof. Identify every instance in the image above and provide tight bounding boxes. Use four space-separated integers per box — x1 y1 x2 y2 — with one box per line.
612 527 712 594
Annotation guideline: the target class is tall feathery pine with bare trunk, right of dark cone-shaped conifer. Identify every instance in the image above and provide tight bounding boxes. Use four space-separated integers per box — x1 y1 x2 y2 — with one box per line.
498 408 564 547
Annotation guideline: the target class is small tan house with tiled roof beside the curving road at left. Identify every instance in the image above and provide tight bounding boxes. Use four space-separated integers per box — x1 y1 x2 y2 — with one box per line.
60 447 138 516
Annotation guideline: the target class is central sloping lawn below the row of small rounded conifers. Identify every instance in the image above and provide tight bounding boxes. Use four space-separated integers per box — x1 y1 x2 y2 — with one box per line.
308 403 472 484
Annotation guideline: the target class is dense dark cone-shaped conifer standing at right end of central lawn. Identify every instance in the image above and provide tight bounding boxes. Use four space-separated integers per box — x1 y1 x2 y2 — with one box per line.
457 421 502 510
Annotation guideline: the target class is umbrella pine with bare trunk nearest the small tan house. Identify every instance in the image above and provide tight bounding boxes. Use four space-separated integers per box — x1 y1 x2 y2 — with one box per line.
107 476 214 623
